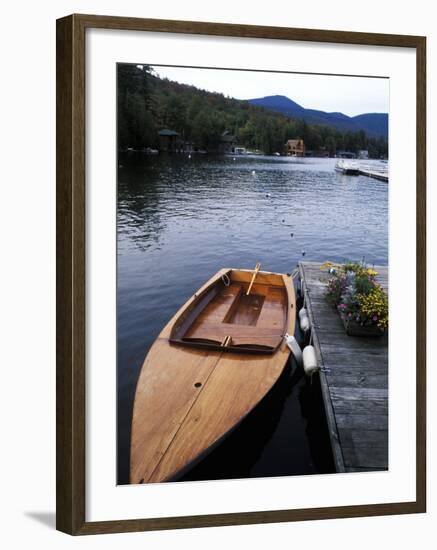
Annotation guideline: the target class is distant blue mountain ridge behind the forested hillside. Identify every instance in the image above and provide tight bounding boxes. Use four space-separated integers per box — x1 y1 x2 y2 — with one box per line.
248 95 388 139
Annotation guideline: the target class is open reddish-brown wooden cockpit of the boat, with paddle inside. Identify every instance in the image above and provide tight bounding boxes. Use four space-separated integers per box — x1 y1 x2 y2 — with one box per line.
170 270 288 353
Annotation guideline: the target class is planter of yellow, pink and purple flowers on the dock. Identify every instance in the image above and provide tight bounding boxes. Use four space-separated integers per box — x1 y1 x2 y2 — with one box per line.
324 262 388 336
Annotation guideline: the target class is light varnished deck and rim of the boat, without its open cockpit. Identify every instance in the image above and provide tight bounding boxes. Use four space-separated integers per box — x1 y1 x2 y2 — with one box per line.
130 269 295 483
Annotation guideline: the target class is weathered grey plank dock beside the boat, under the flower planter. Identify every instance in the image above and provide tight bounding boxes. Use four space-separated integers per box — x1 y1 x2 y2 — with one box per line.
299 262 388 472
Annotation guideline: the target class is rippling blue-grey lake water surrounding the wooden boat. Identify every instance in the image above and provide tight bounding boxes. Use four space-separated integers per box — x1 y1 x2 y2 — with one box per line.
117 153 388 483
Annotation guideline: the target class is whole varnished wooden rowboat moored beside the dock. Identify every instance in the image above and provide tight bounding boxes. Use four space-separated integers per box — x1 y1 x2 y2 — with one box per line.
130 269 296 483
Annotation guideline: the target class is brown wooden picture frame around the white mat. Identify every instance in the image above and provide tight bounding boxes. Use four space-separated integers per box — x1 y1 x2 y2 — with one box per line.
56 15 426 535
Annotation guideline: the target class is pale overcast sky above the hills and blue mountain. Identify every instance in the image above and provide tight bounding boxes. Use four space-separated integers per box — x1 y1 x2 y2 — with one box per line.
153 65 389 116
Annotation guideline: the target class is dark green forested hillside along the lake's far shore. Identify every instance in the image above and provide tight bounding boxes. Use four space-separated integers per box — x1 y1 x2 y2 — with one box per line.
117 64 388 158
